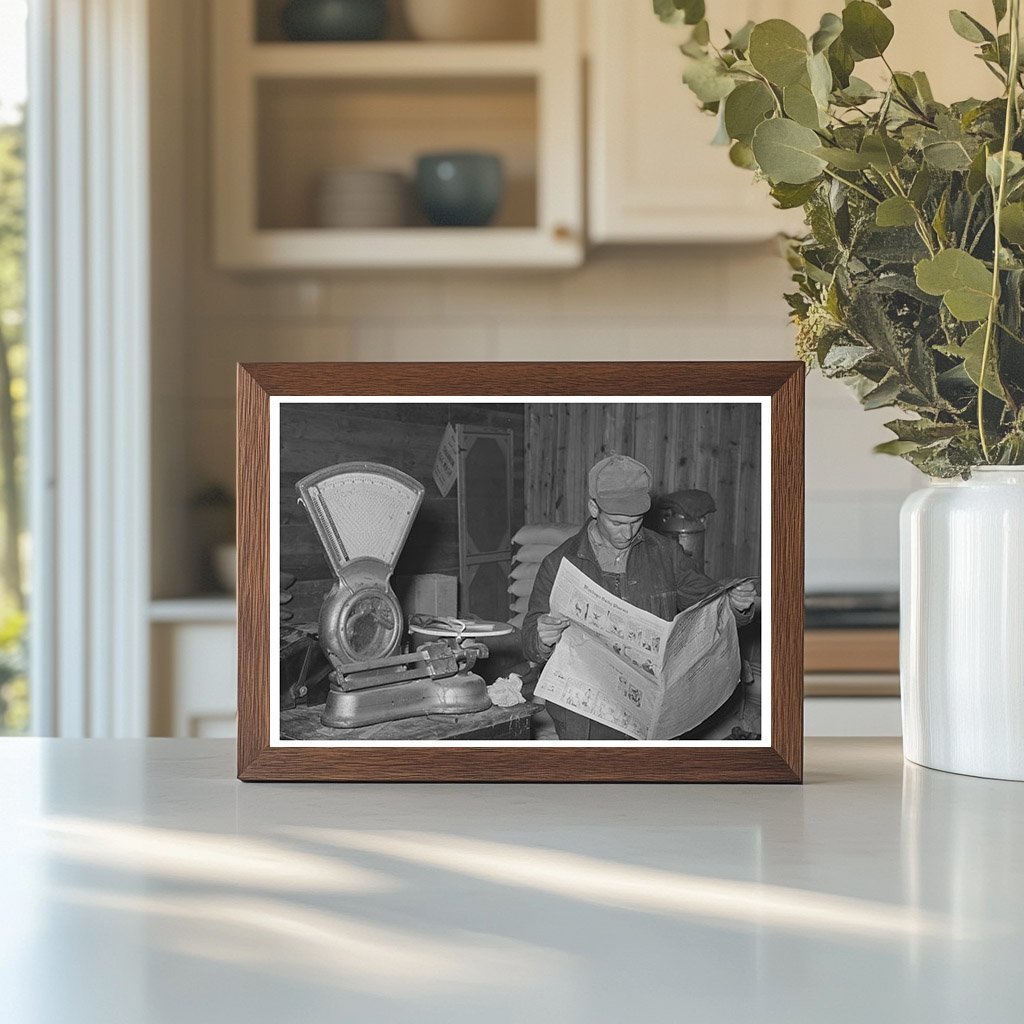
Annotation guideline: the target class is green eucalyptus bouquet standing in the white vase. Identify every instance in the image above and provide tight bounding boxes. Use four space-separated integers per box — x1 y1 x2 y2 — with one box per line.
654 0 1024 477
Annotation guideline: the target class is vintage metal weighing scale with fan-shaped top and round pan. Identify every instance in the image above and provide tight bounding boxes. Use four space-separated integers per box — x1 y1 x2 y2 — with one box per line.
296 462 511 729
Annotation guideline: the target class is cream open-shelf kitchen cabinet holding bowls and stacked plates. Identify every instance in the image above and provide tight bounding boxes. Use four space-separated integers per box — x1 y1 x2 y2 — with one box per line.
211 0 584 269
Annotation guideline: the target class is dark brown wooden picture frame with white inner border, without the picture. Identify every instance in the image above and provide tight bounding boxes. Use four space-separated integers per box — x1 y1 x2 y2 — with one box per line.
237 361 804 782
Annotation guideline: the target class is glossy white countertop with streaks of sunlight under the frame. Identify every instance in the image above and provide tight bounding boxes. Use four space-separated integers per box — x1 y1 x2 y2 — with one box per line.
0 739 1024 1024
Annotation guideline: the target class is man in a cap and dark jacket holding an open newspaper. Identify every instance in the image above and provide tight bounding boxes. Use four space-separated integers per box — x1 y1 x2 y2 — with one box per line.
523 455 755 739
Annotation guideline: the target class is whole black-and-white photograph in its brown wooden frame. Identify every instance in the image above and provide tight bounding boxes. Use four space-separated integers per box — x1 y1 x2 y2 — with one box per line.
238 361 804 782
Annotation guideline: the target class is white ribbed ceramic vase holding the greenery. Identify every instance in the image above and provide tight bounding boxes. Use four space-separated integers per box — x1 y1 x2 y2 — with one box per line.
900 466 1024 780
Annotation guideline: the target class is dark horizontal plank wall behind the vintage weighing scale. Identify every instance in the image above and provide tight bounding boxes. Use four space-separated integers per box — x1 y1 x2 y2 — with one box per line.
280 402 524 622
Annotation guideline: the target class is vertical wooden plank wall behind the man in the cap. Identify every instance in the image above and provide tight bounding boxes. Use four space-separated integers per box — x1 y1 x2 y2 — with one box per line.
525 402 761 579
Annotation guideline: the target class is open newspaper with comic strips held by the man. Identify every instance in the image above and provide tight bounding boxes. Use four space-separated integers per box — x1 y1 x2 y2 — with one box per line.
536 558 756 739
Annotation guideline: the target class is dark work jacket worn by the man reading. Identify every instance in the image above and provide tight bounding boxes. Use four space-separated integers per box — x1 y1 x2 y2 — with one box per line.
522 521 754 662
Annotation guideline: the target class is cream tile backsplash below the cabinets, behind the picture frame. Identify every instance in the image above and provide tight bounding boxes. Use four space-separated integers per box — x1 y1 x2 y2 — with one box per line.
178 245 916 590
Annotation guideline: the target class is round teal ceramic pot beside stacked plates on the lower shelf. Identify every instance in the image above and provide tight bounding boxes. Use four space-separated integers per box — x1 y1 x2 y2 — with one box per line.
416 153 505 227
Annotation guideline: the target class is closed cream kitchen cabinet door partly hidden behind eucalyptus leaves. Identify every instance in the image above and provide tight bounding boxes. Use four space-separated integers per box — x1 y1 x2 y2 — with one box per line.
586 0 997 244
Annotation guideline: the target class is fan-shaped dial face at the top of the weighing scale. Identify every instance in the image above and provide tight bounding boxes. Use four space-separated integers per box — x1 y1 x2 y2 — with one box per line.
297 462 424 577
